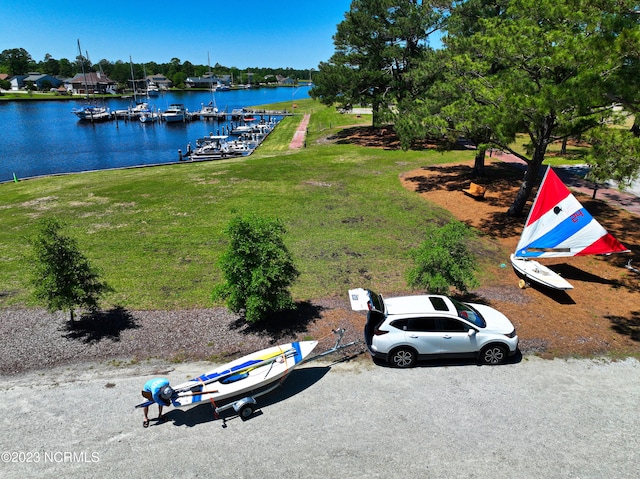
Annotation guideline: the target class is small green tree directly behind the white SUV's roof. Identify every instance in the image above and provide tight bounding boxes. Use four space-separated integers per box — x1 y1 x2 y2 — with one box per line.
407 221 479 294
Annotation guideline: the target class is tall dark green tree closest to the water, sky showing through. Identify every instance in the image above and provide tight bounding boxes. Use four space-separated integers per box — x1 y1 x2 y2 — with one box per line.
309 0 442 126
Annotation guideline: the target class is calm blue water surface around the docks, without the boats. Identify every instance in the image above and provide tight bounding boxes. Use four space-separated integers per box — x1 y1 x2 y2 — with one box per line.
0 86 309 182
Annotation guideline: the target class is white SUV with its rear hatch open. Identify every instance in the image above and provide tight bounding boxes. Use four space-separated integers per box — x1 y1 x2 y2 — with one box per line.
349 288 518 368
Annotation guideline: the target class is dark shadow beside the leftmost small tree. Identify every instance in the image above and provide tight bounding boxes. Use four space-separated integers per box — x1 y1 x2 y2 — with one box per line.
64 306 140 344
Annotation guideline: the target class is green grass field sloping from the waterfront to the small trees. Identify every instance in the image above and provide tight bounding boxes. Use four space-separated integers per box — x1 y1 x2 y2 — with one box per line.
0 100 480 309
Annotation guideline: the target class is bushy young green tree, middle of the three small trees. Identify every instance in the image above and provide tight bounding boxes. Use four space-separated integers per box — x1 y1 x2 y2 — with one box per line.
213 214 299 323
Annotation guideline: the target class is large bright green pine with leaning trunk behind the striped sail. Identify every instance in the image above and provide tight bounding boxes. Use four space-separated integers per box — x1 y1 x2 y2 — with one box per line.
445 0 638 216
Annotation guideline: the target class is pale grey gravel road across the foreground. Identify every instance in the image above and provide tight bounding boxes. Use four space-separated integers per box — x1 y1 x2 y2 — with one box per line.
0 356 640 479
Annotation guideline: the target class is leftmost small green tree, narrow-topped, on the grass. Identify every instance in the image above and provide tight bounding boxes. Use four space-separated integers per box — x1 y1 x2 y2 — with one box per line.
32 219 111 321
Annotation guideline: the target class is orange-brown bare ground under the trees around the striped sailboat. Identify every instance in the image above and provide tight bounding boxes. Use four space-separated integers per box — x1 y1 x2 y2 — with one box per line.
400 161 640 356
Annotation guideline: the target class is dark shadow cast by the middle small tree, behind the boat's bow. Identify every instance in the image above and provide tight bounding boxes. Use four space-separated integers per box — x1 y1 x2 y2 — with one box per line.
231 301 325 343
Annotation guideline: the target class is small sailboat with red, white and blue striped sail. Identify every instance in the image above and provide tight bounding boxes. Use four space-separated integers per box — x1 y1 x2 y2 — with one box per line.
511 167 629 290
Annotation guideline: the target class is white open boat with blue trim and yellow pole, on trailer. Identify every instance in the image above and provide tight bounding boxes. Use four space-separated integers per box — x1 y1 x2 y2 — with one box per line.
171 341 318 407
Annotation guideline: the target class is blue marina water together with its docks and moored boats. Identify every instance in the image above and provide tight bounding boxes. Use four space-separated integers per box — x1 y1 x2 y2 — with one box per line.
0 86 310 182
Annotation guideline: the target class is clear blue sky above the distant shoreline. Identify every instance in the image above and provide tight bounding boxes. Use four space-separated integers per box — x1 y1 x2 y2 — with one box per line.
0 0 351 69
